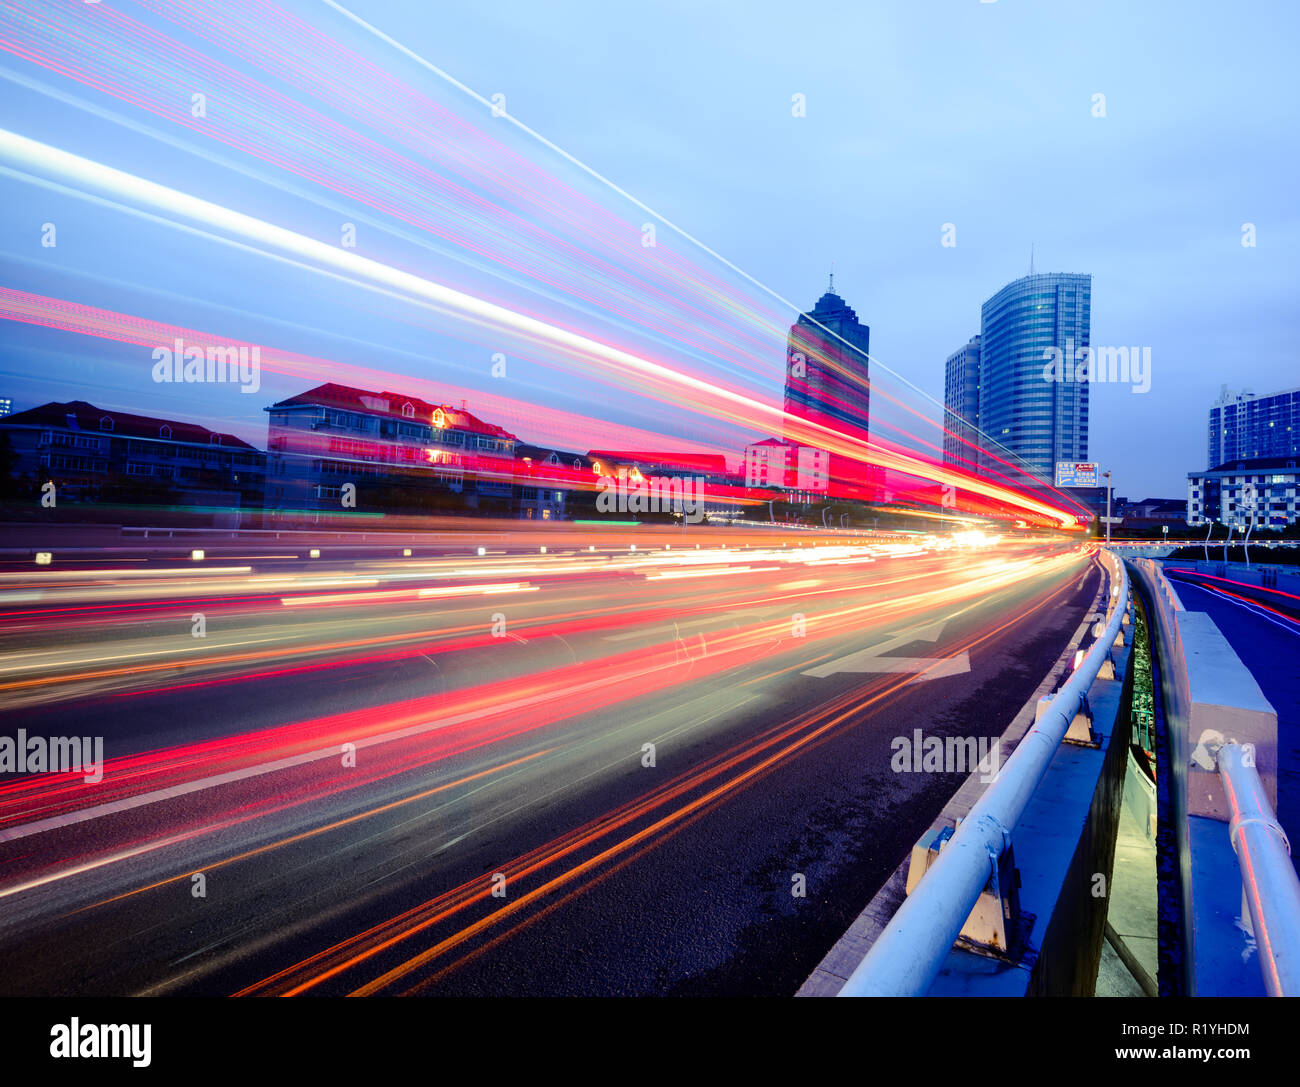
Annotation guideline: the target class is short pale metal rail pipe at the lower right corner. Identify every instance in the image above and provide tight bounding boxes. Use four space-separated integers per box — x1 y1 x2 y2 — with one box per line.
1218 744 1300 996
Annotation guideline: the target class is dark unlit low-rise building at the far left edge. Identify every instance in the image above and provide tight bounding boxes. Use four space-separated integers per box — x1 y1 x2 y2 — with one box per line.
0 400 265 521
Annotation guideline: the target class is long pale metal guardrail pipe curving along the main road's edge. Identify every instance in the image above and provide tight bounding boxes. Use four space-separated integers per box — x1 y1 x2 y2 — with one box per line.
839 551 1128 996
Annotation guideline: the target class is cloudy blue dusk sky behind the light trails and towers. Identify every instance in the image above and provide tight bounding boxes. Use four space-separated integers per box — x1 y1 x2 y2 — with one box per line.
0 0 1300 498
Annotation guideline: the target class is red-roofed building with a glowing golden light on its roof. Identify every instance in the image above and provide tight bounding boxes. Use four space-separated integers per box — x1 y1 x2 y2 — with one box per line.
267 382 516 516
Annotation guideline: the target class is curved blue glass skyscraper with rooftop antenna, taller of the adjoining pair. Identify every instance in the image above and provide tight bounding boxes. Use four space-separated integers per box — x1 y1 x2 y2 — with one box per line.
976 272 1092 482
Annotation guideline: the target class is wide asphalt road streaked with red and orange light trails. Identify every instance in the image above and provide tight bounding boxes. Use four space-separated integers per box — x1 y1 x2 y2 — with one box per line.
0 544 1097 995
